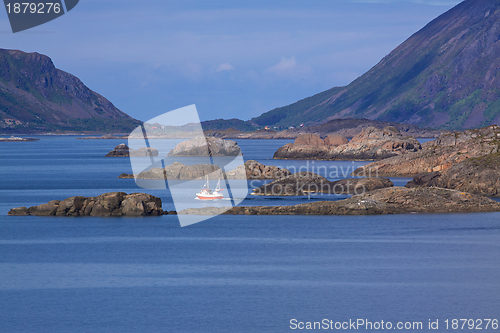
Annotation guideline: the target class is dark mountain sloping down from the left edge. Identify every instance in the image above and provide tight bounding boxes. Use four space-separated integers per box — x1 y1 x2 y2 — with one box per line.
0 49 141 134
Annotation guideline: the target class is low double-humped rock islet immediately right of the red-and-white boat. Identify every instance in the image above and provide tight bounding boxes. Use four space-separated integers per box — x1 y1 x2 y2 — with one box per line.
251 171 394 196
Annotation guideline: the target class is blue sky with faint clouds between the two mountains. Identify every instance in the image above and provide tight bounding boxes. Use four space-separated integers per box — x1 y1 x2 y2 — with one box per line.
0 0 461 121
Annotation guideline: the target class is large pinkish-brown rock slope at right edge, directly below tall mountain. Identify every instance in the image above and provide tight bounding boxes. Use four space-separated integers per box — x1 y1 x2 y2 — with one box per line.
353 125 500 177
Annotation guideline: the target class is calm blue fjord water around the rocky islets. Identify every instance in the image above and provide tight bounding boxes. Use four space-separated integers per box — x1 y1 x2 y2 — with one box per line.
0 136 500 333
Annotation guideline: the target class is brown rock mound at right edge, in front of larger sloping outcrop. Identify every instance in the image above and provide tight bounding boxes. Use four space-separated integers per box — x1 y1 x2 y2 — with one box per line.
406 153 500 197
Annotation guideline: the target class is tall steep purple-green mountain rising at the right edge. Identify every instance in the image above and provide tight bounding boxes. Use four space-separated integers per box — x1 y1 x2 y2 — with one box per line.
251 0 500 129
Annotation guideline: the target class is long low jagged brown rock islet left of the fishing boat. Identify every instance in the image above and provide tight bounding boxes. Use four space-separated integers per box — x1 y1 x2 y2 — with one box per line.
8 192 165 216
